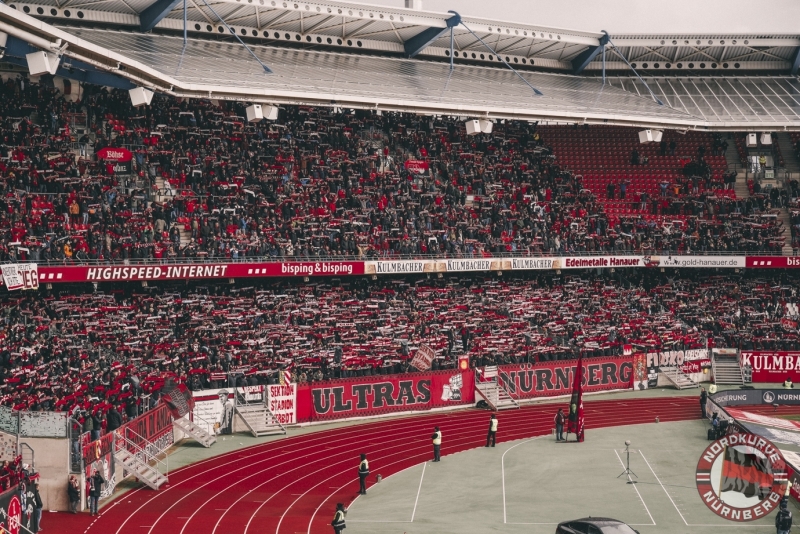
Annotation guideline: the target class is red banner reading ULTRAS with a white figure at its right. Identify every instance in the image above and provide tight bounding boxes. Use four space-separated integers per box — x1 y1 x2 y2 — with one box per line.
303 369 475 420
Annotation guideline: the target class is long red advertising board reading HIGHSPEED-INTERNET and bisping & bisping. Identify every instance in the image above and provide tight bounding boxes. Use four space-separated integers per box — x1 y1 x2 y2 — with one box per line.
39 261 364 283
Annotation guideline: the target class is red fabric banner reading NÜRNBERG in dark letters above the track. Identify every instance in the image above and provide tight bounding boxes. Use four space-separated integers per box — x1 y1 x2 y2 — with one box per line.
498 356 633 399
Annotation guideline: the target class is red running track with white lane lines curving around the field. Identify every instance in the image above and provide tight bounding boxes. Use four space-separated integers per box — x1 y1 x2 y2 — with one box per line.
53 397 700 534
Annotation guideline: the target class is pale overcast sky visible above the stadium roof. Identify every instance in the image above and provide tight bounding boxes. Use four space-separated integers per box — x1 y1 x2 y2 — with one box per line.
364 0 800 36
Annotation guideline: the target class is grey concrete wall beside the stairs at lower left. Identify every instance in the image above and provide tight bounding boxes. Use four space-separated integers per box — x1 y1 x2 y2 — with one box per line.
19 438 69 511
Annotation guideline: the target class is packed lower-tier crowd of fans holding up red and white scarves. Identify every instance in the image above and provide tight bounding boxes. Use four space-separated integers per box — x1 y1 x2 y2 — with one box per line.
0 270 800 422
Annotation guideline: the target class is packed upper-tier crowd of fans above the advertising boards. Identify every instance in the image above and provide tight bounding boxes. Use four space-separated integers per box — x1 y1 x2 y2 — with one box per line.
0 78 784 262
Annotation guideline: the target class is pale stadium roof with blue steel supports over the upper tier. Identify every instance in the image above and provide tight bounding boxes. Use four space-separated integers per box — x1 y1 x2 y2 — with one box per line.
0 0 800 130
